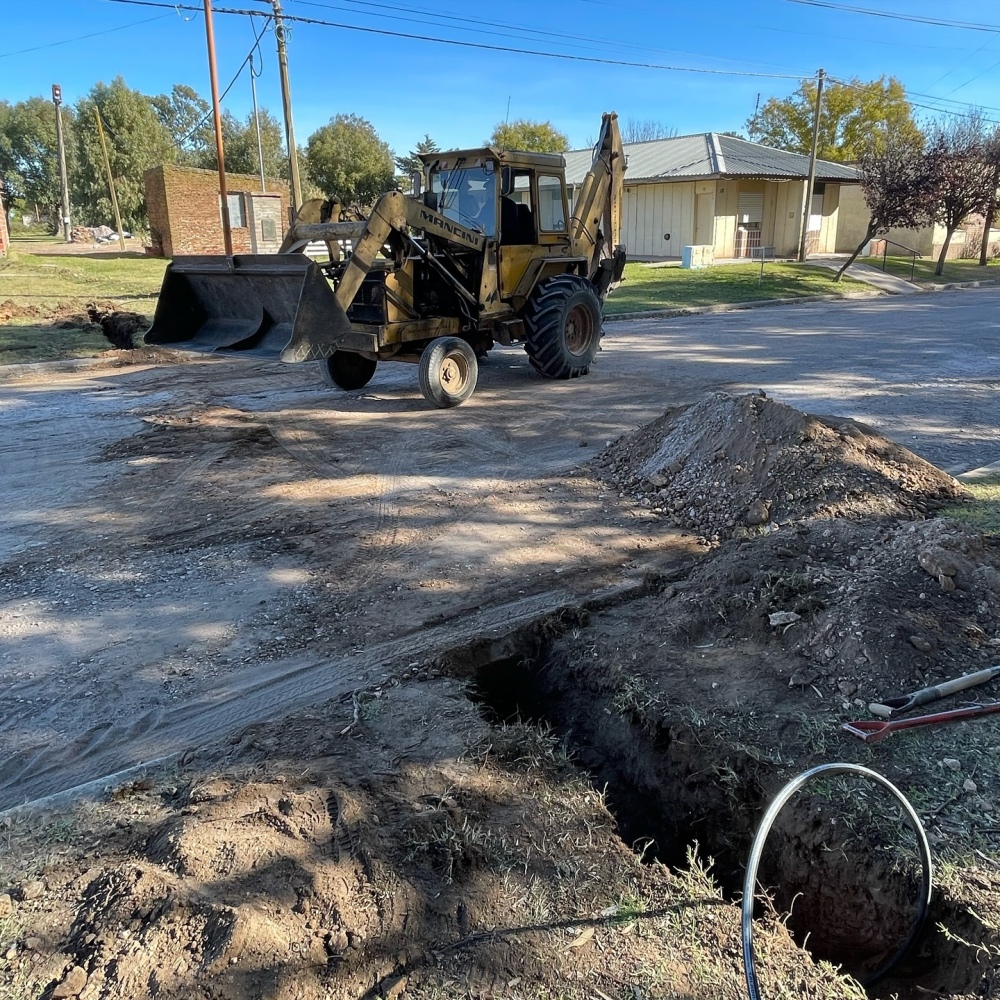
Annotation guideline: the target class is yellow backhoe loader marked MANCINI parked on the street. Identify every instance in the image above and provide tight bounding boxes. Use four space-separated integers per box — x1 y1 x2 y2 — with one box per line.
146 114 625 407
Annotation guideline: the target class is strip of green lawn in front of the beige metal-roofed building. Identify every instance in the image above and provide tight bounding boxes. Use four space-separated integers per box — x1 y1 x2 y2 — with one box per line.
604 263 870 316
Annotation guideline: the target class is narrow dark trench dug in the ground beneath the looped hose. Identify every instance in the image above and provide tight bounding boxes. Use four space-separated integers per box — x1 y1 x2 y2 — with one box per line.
450 629 992 1000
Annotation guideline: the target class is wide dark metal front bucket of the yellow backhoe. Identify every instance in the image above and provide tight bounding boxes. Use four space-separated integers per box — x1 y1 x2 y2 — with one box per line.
146 254 352 361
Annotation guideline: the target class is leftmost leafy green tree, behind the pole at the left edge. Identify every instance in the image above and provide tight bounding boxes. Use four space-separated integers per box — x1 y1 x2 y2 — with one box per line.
0 97 74 225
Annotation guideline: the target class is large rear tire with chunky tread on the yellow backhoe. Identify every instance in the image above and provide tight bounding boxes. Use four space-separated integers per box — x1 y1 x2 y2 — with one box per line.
523 274 602 379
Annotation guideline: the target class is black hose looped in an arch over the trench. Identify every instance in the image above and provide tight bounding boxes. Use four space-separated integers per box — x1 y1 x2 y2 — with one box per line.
742 764 933 1000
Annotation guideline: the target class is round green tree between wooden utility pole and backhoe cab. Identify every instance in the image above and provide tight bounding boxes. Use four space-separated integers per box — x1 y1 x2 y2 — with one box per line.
306 115 394 205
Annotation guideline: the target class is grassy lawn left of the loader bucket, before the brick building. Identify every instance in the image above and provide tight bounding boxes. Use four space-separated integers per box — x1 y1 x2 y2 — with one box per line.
0 237 167 364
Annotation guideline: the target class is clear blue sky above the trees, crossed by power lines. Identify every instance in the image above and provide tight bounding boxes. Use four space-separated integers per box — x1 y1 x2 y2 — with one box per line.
0 0 1000 153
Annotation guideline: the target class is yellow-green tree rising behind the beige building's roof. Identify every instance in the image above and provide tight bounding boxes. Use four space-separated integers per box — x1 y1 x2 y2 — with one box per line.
746 76 920 163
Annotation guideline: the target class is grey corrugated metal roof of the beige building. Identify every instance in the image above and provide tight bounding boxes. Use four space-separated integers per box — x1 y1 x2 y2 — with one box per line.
563 132 858 184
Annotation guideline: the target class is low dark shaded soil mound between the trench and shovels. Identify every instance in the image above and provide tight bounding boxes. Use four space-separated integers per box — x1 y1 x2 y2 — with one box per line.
660 518 1000 705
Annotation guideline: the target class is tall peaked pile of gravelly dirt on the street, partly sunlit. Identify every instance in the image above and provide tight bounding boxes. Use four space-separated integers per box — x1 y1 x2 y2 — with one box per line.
593 392 962 540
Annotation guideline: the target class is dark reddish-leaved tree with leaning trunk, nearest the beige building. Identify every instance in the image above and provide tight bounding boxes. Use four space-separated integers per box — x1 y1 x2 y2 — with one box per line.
836 132 934 281
